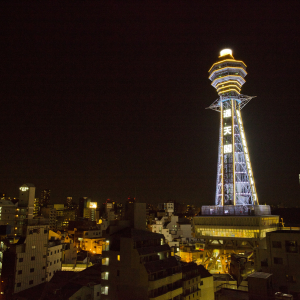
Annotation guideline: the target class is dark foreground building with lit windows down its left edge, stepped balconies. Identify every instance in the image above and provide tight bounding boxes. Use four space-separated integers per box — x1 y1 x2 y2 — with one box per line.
101 227 182 300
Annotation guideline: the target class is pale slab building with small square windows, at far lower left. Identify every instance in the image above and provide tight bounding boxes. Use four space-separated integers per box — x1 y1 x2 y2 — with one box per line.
1 220 48 297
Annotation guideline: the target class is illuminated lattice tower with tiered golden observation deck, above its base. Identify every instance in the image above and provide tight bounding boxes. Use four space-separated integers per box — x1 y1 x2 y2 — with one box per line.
208 49 258 206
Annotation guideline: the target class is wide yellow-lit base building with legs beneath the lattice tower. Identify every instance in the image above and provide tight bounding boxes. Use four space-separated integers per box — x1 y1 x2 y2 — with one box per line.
193 215 279 273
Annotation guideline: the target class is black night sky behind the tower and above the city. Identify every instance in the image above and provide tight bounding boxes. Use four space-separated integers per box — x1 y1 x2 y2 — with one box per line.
0 1 300 206
